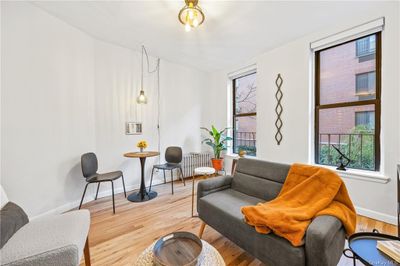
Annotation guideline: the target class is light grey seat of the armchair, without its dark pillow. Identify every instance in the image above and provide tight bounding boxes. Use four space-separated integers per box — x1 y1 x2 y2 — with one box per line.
1 210 90 266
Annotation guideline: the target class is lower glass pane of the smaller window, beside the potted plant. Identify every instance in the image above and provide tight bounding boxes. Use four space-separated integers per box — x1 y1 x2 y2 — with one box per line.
233 116 256 156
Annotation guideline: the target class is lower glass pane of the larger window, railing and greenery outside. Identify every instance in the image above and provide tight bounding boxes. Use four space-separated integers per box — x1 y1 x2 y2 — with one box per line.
318 105 375 170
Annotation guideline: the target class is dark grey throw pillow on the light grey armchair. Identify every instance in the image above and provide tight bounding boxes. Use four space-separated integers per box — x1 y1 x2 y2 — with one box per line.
0 201 29 248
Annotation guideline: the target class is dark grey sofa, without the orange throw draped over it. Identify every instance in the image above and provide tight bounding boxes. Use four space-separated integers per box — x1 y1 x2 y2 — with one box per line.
197 158 345 266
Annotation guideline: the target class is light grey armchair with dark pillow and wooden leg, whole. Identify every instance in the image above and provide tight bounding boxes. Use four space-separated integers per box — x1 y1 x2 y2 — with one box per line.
0 192 90 266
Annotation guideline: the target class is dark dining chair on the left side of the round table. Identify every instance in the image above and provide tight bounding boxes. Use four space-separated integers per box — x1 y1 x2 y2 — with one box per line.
79 152 126 214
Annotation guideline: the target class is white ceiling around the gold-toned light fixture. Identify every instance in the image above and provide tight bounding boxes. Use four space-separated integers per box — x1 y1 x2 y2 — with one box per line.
34 0 379 71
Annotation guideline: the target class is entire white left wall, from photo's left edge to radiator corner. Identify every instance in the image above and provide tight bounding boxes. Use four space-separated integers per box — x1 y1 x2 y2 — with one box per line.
1 2 208 217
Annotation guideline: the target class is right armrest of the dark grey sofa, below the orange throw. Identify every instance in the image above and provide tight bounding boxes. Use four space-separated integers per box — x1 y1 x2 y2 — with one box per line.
305 215 346 266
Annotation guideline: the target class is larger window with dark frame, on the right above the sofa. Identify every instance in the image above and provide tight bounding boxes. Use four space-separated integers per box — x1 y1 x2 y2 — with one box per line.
315 33 381 171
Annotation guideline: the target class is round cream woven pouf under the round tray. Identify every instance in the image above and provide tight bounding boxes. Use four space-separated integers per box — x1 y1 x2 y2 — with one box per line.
133 240 225 266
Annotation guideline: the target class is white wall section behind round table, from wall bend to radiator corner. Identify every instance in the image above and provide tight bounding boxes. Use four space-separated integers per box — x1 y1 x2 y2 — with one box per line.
95 41 207 192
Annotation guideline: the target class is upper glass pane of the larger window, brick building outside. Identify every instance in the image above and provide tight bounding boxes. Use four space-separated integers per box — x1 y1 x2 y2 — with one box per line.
319 35 376 105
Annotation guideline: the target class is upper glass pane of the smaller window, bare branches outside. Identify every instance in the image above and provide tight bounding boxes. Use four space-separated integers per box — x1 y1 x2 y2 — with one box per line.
234 73 256 114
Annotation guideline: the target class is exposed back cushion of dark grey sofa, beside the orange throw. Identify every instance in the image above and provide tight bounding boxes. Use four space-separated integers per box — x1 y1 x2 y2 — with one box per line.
232 158 290 201
